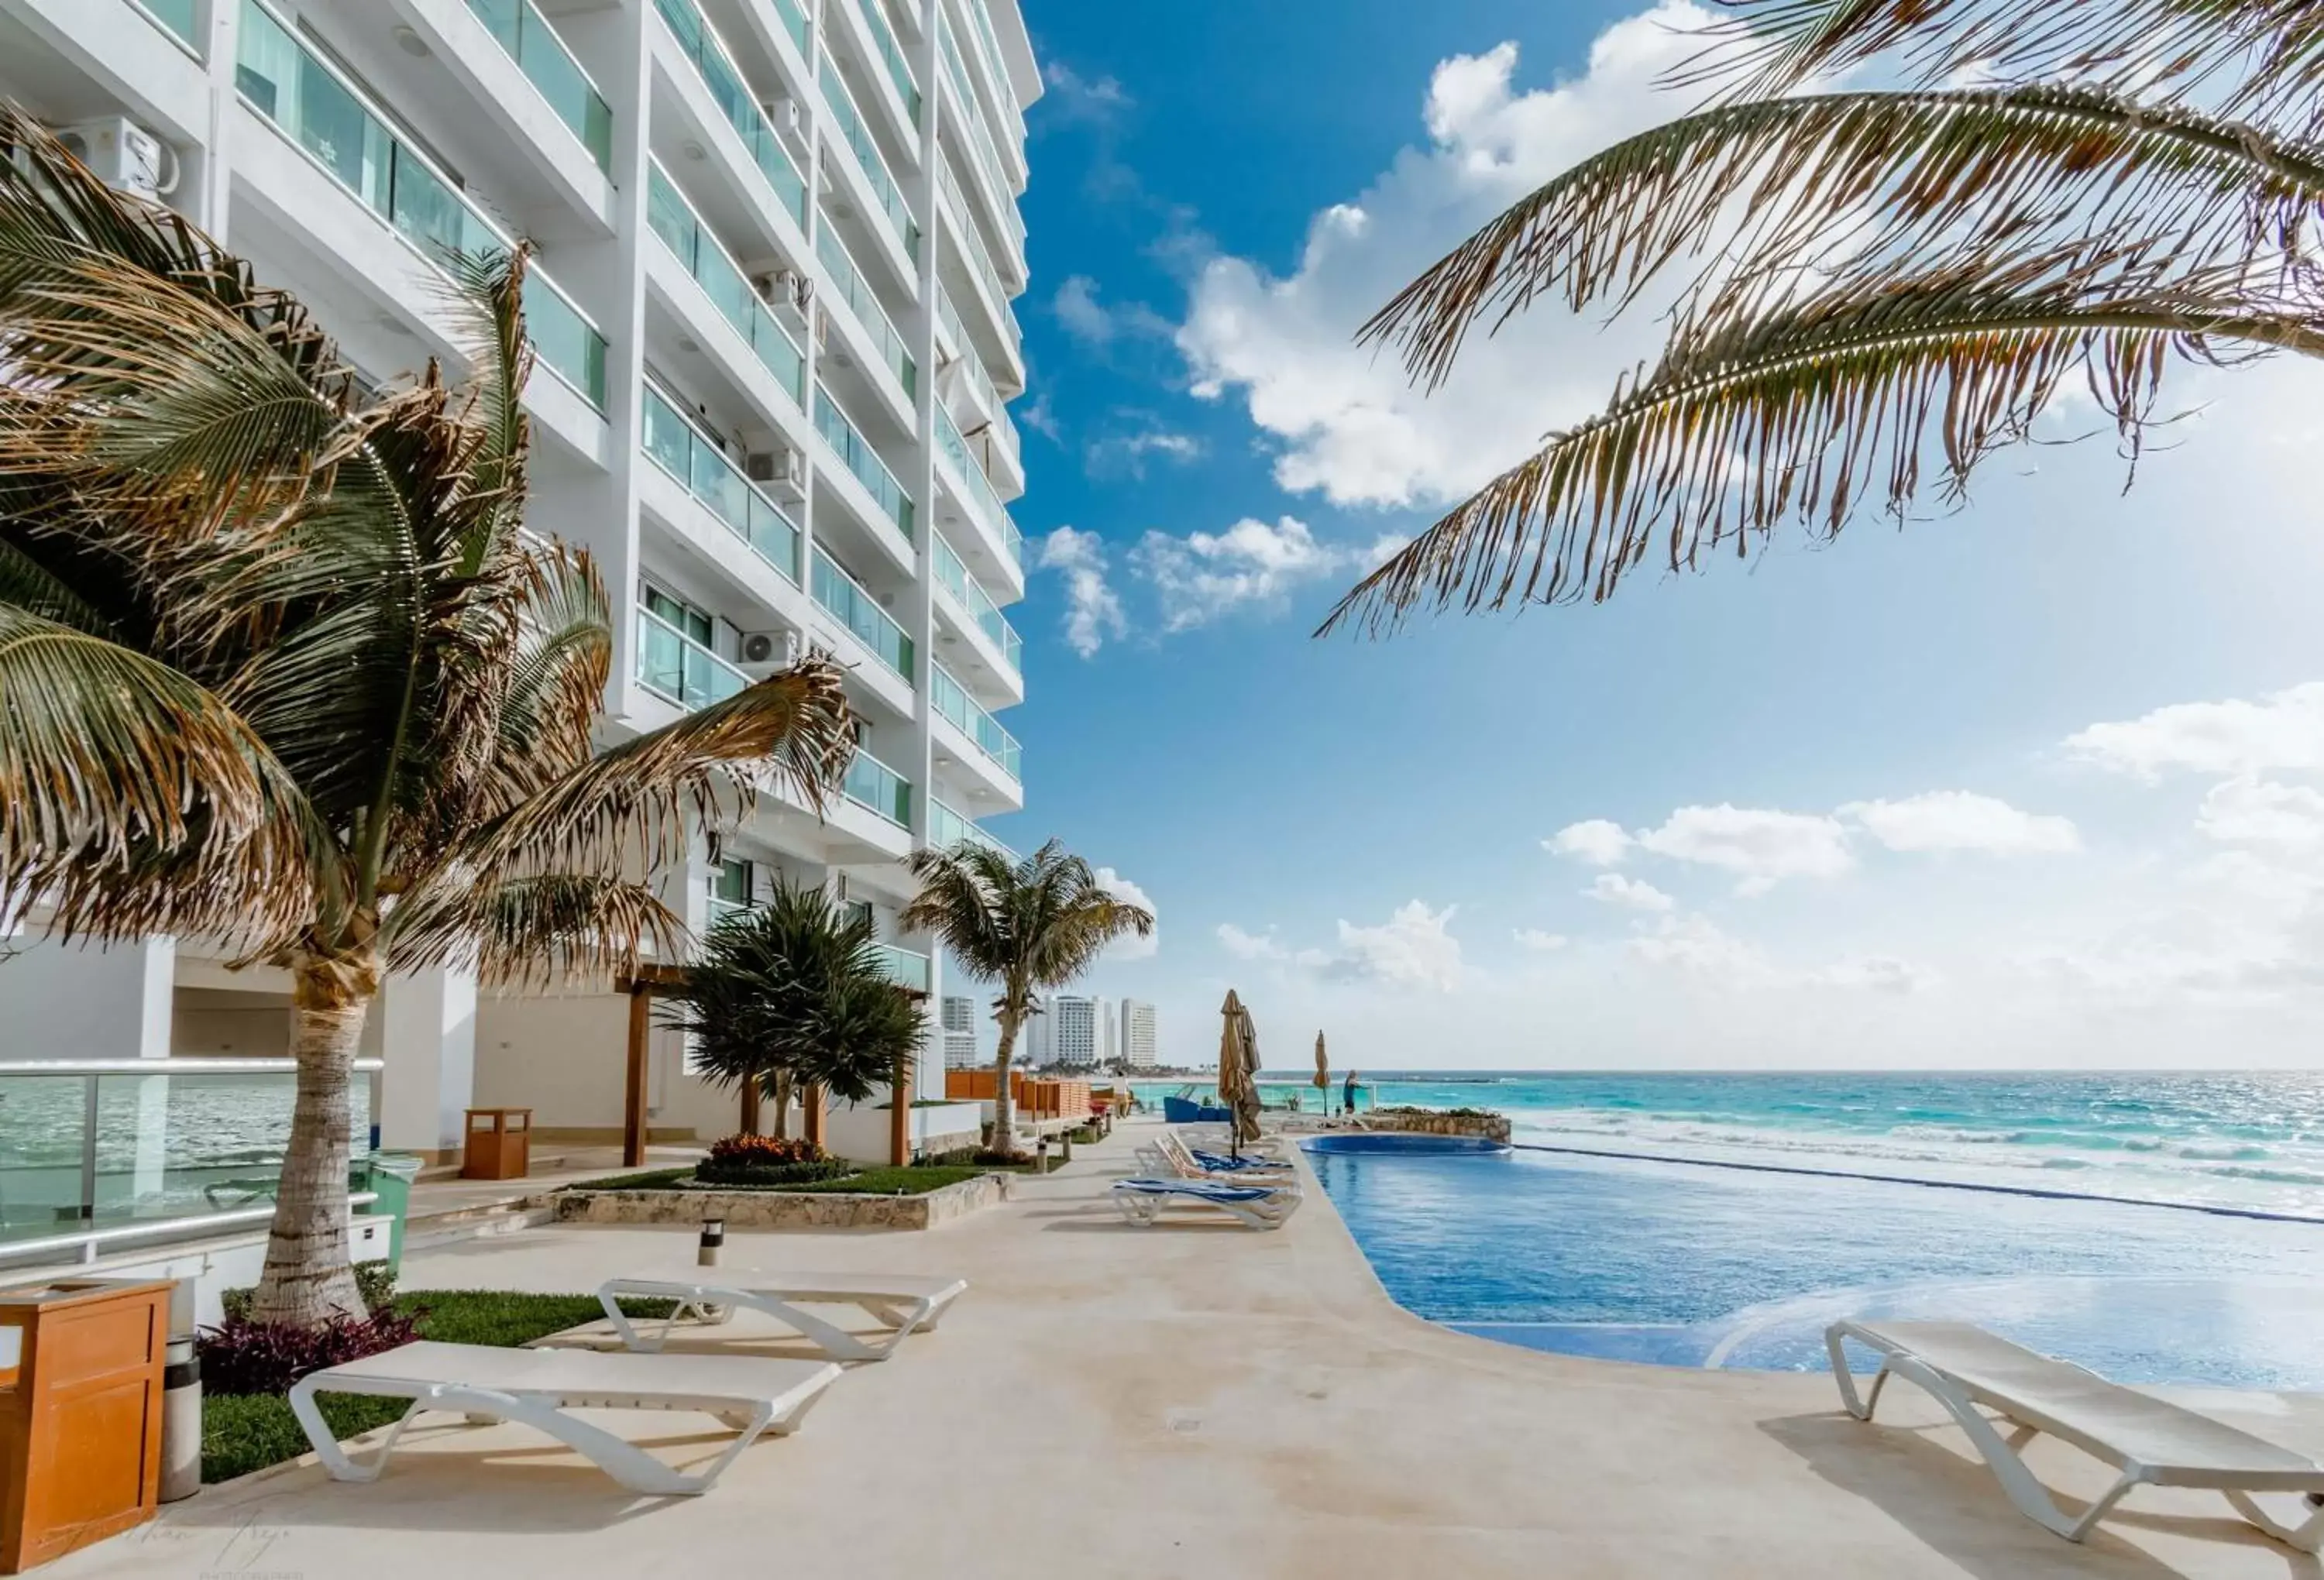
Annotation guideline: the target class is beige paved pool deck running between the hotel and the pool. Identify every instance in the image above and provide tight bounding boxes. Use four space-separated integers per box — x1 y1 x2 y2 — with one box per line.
42 1125 2324 1580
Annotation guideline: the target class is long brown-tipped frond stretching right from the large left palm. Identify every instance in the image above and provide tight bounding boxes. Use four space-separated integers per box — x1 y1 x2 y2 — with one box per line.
453 658 855 874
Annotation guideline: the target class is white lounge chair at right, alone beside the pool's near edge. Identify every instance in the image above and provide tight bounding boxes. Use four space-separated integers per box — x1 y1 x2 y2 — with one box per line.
1824 1322 2324 1552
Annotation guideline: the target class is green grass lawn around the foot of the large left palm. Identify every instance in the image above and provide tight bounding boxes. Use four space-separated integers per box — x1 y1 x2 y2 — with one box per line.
202 1290 667 1482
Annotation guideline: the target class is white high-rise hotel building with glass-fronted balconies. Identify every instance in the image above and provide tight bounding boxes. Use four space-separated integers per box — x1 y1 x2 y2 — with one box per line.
0 0 1041 1185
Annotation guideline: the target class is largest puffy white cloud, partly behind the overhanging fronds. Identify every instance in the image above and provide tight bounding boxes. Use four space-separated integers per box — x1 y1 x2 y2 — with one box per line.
1178 0 1710 507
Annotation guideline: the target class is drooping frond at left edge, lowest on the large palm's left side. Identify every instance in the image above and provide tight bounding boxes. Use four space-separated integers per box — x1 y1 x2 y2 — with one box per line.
0 604 328 939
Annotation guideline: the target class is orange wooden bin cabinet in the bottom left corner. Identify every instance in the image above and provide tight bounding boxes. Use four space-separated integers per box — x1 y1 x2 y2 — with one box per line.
0 1278 177 1575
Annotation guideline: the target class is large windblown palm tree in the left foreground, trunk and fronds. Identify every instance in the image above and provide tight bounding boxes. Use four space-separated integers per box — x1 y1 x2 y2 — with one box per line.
0 109 851 1324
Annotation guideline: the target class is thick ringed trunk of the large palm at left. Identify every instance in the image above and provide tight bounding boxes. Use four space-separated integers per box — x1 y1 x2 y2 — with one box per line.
251 955 379 1327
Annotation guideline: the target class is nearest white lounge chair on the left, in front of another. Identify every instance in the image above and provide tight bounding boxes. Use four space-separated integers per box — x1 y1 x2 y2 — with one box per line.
290 1341 841 1496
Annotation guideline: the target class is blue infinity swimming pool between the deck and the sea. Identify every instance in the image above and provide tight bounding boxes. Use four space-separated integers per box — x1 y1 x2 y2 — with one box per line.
1308 1146 2324 1389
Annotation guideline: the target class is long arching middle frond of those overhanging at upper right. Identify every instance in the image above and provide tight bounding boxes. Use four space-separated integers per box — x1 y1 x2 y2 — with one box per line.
1362 86 2324 386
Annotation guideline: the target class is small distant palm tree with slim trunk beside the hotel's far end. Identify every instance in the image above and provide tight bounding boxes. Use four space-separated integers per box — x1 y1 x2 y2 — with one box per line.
897 839 1155 1152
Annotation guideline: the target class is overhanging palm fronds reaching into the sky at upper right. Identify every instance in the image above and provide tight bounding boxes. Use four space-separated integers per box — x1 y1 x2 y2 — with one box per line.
1325 0 2324 632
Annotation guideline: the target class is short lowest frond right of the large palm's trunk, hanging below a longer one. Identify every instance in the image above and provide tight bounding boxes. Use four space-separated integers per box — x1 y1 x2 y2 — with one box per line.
379 867 686 988
